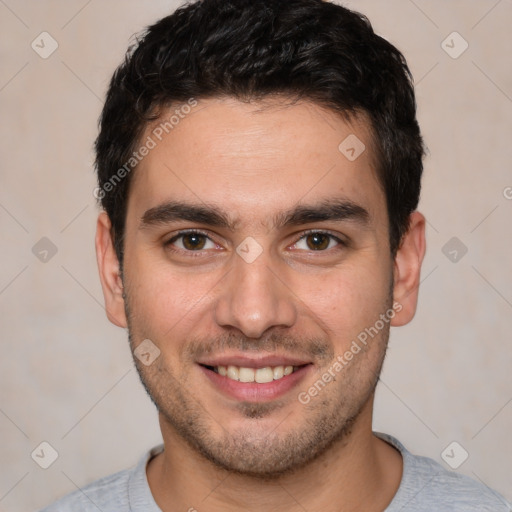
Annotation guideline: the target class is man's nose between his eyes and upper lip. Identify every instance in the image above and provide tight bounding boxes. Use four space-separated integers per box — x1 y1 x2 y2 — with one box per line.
215 245 297 338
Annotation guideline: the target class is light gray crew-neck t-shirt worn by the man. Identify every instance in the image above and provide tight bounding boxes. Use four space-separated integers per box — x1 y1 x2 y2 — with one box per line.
40 432 512 512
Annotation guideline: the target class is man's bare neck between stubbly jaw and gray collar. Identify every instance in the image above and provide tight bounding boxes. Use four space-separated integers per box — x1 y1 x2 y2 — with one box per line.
146 396 403 512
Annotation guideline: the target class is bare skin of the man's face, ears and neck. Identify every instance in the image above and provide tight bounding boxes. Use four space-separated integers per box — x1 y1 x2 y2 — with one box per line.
96 98 425 512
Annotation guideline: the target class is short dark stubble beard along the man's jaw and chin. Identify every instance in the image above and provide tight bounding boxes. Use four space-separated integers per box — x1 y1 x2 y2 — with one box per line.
125 297 389 480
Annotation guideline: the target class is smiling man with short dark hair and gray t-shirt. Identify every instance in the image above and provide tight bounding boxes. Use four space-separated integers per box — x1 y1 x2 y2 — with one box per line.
39 0 510 512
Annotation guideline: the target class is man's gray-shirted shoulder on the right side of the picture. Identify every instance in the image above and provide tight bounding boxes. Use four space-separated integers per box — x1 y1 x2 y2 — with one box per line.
376 433 512 512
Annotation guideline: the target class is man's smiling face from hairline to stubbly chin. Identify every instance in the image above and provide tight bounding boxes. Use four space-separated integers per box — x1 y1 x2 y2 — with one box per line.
98 99 424 477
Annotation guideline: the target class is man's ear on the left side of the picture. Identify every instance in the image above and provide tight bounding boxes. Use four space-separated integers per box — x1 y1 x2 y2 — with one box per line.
96 212 127 327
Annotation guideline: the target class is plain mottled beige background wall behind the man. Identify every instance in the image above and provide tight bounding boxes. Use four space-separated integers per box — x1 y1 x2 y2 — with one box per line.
0 0 512 512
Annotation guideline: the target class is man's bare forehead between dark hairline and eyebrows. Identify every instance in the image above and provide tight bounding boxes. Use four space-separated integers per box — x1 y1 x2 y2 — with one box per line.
128 98 385 230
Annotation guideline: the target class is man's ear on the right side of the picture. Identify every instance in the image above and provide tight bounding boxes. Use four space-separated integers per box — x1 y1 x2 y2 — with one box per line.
391 211 426 326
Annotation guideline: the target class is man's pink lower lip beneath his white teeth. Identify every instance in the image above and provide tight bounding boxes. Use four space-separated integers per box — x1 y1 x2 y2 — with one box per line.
198 364 313 402
